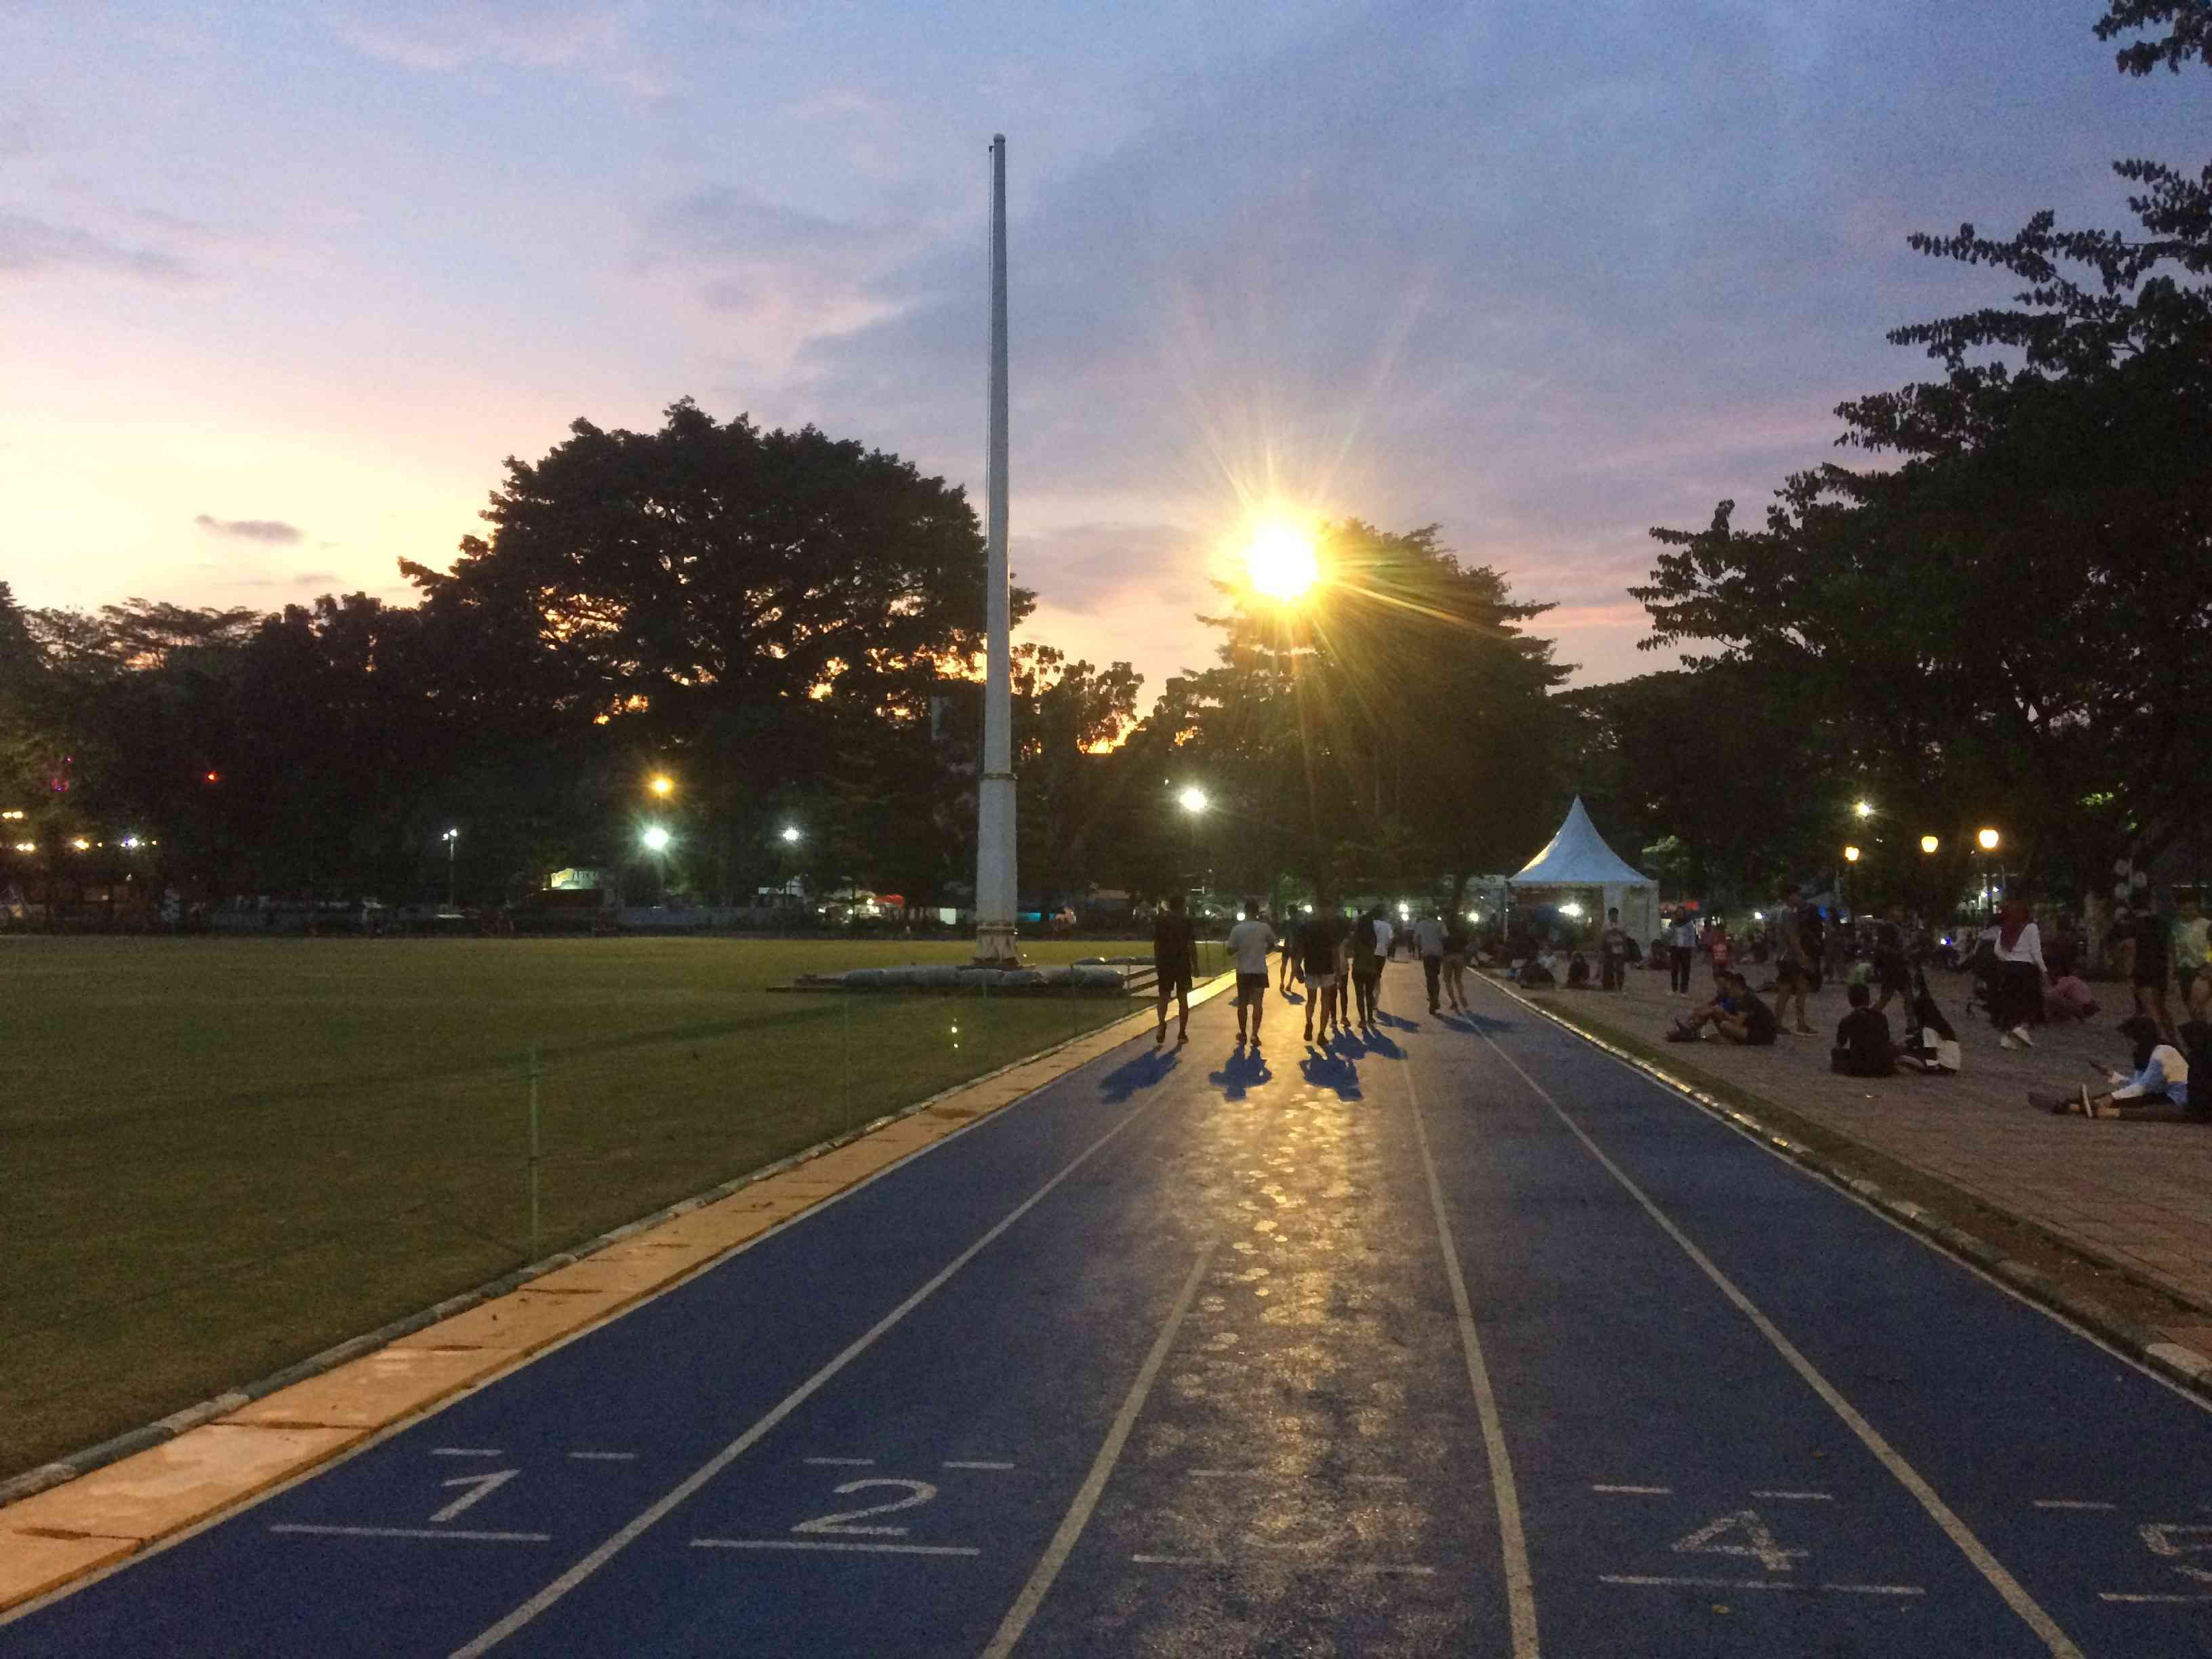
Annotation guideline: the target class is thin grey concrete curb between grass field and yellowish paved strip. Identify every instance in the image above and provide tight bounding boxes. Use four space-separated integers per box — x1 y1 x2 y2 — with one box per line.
0 973 1234 1509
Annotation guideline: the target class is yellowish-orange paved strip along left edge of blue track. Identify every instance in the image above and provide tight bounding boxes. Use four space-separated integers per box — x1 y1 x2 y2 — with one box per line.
0 973 1237 1610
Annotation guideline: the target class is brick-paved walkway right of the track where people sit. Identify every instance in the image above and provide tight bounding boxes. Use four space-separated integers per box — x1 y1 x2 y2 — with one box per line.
1542 964 2212 1347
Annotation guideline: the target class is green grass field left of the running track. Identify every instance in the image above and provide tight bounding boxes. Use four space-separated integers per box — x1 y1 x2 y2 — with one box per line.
0 938 1212 1475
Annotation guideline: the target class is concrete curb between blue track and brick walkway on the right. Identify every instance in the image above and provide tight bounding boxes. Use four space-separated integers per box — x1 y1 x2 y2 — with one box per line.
1482 973 2212 1400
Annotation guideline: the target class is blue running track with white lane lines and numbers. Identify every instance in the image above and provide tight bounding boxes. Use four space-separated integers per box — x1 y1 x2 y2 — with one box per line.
0 966 2212 1659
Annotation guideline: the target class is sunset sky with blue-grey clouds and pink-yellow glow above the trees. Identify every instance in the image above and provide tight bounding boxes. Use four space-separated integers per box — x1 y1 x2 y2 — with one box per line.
0 0 2205 699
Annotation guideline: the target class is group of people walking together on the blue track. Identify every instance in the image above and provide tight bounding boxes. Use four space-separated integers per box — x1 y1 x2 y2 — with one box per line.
1153 894 1471 1048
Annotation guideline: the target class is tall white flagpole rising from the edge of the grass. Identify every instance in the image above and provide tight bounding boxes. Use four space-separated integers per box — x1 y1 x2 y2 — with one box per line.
975 133 1020 966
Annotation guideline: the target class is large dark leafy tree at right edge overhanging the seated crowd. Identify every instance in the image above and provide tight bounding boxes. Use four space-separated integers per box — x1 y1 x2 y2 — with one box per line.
1631 5 2212 898
